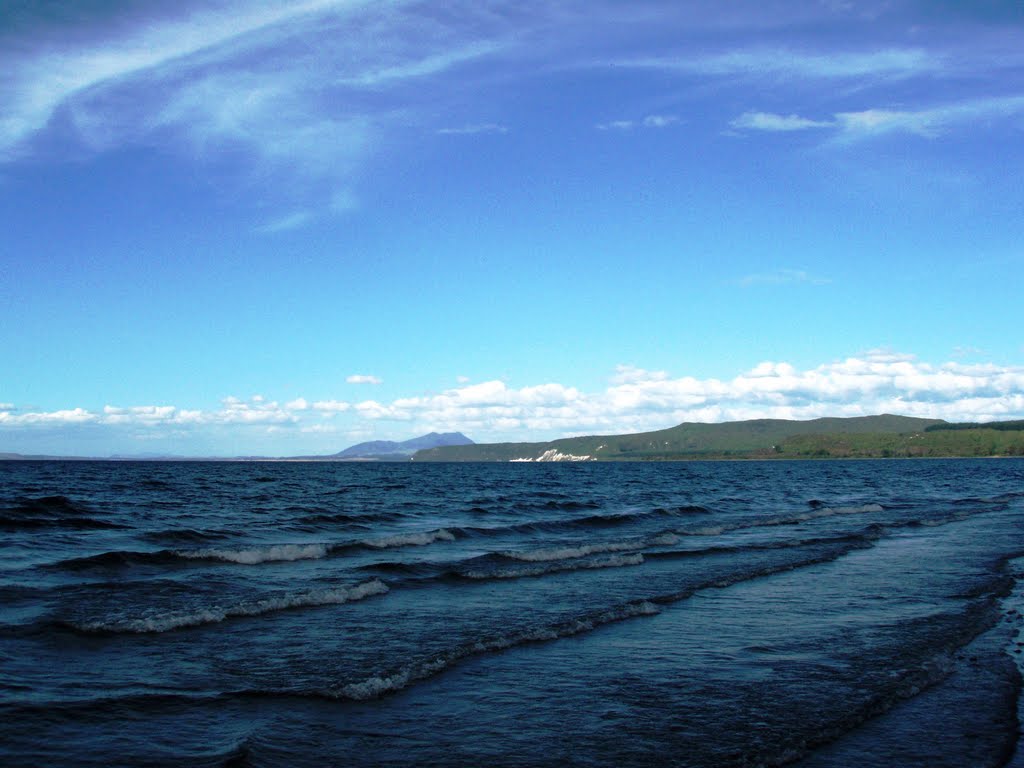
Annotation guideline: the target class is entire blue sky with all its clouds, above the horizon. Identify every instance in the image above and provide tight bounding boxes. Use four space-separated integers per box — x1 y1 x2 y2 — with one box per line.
0 0 1024 456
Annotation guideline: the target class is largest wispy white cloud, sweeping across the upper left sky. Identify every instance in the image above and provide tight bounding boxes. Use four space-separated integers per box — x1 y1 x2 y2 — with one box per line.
0 0 504 217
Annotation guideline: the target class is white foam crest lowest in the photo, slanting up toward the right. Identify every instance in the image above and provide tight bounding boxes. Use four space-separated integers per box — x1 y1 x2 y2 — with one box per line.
325 600 662 700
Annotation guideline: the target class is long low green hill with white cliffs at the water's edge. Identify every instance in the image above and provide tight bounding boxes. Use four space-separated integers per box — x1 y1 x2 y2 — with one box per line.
414 414 1024 462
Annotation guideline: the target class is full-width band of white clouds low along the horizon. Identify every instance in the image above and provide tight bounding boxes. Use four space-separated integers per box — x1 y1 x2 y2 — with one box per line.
0 350 1024 453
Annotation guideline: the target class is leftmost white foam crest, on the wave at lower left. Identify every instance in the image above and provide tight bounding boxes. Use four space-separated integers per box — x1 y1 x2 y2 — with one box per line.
77 579 388 634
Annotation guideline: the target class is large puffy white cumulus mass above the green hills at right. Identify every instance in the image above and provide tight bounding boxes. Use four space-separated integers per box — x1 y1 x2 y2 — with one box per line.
319 350 1024 439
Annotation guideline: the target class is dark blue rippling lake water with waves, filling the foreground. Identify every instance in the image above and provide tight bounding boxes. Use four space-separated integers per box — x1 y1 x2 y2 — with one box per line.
0 460 1024 768
